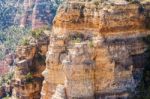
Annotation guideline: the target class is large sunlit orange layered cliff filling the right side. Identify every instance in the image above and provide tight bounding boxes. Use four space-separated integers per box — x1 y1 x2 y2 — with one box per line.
41 0 150 99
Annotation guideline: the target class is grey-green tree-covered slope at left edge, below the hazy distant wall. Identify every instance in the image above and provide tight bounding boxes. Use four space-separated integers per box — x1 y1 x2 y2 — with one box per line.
0 26 30 59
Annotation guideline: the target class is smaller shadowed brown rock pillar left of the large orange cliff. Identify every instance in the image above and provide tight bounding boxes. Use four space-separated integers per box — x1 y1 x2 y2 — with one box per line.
12 31 49 99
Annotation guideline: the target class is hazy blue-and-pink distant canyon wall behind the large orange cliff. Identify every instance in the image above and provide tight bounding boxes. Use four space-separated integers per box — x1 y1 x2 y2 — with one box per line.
0 0 62 29
